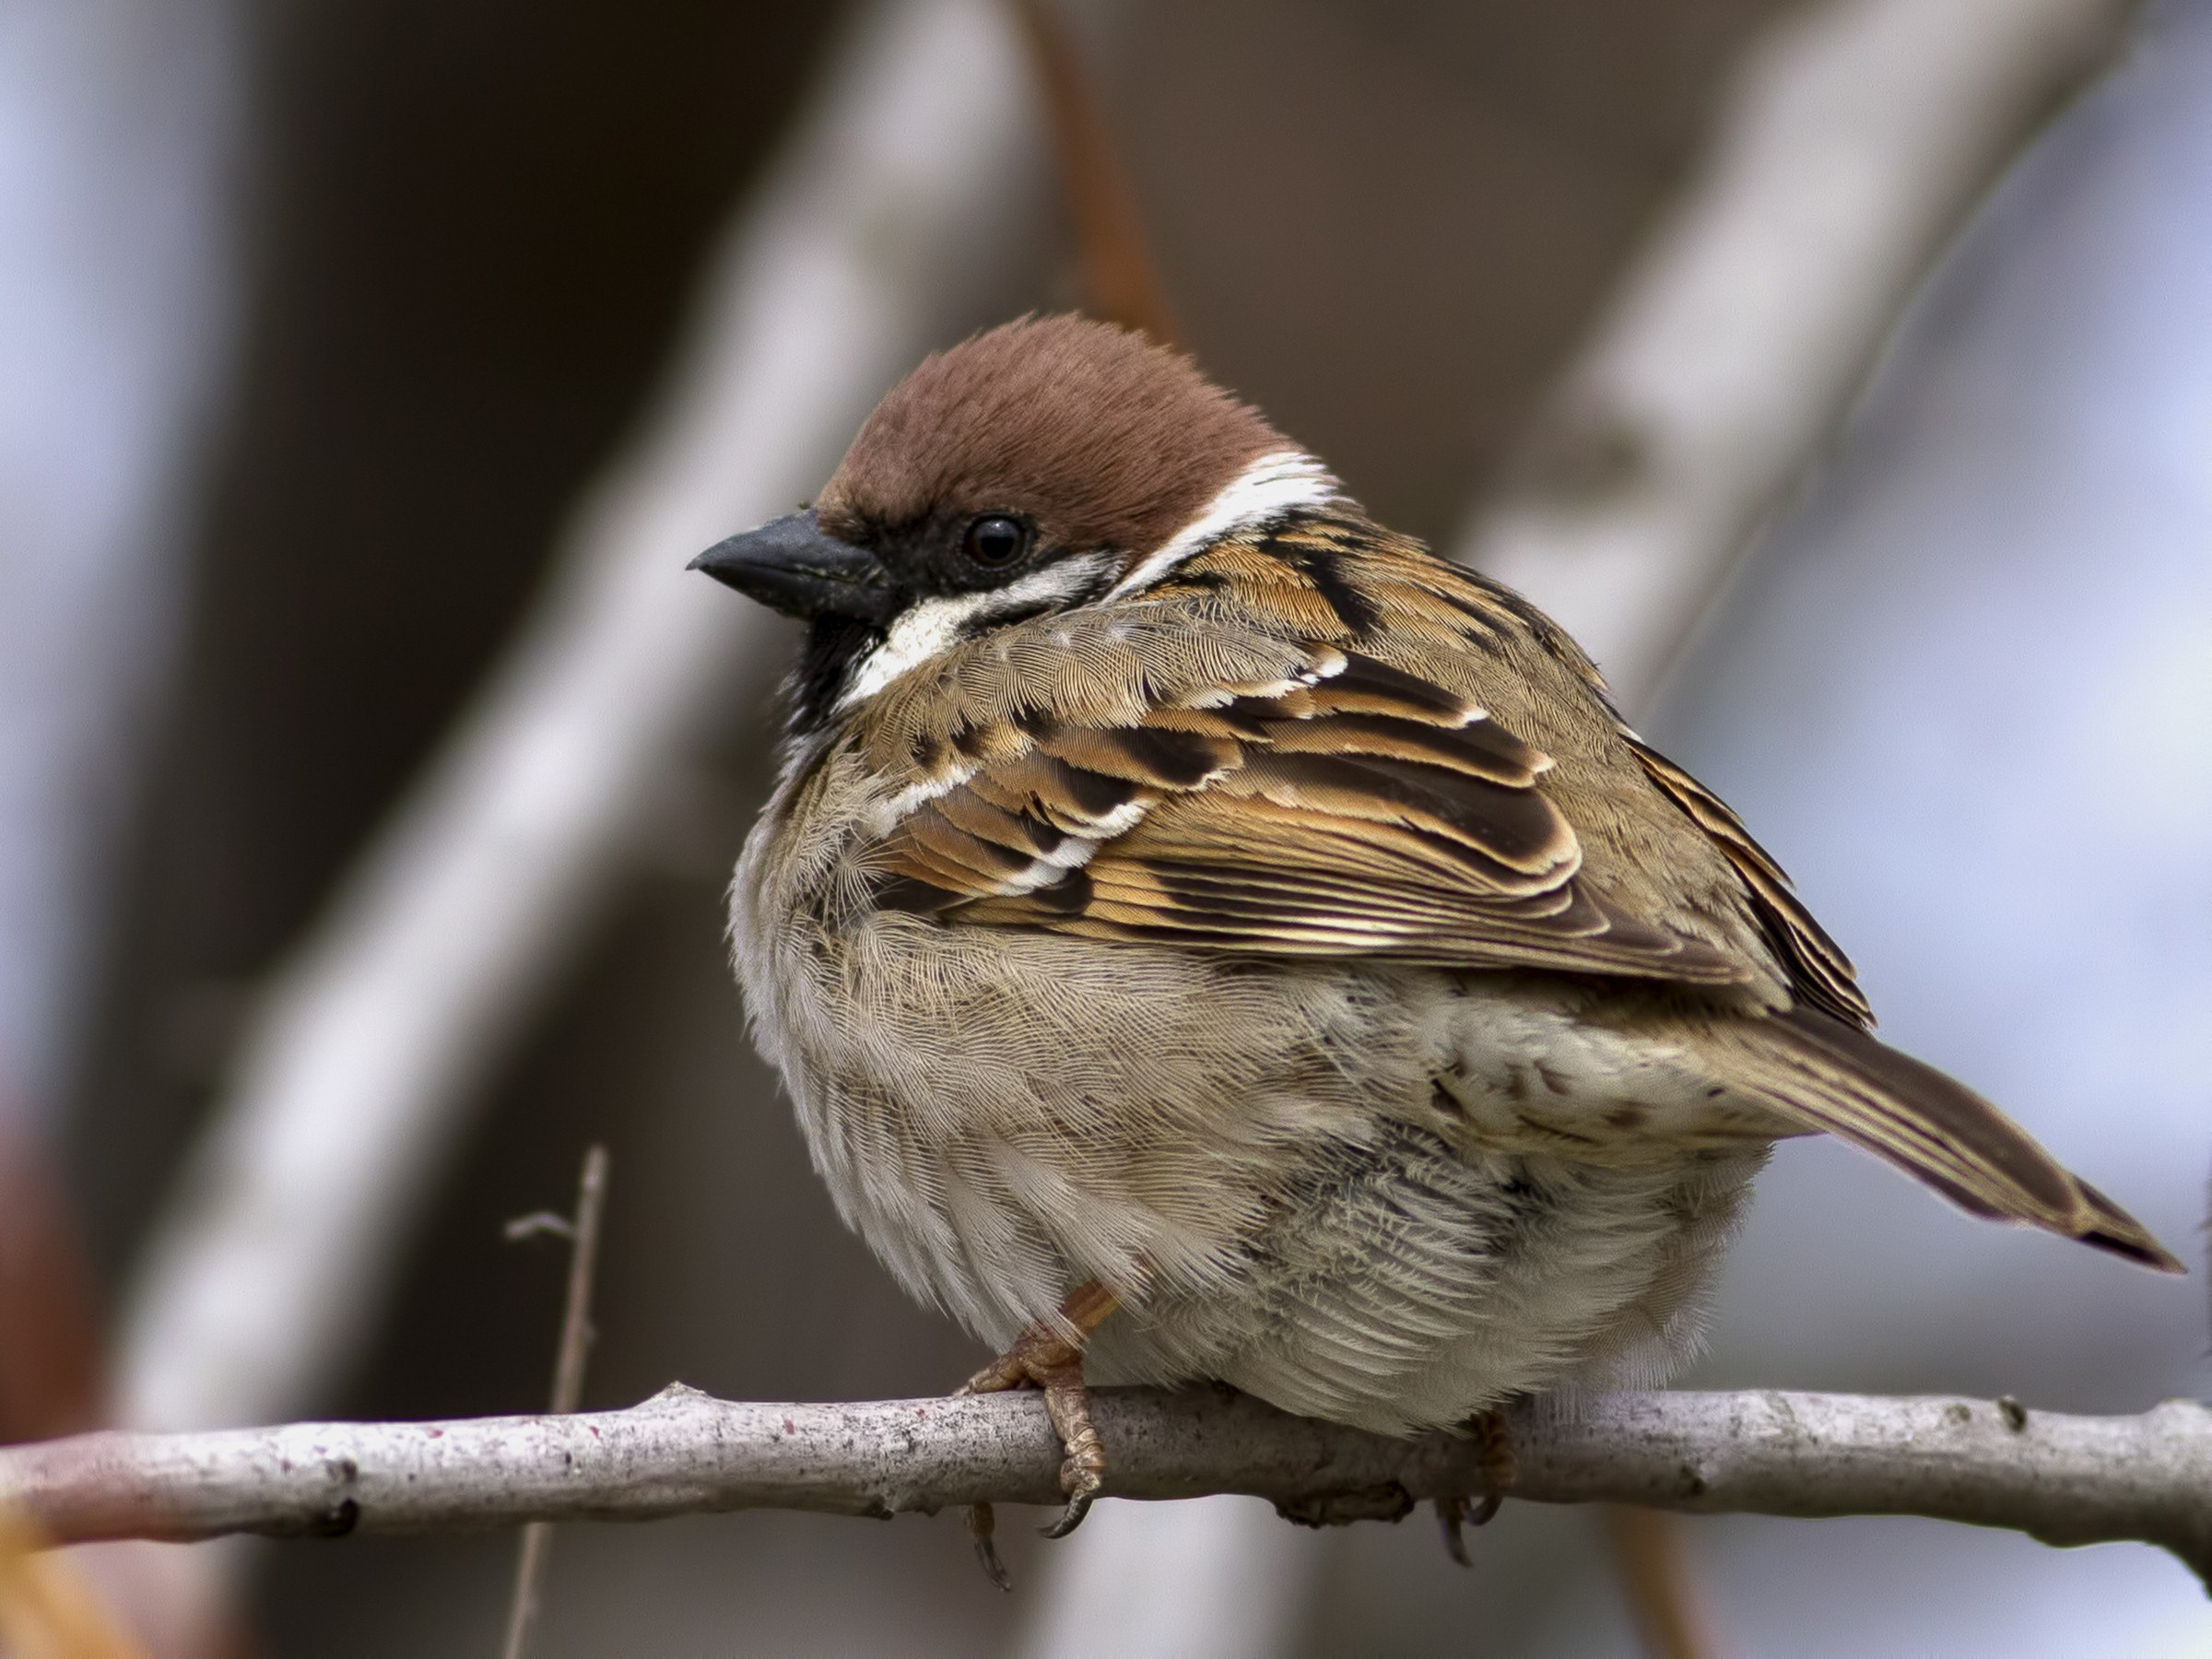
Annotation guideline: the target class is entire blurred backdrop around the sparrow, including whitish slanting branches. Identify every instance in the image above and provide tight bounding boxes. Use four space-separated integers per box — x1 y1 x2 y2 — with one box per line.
0 0 2212 1657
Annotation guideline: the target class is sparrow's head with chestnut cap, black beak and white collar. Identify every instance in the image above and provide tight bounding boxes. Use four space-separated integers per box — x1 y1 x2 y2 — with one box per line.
692 316 1340 728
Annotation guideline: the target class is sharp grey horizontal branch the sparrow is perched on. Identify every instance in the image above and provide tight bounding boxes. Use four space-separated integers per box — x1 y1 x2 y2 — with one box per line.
13 1384 2212 1582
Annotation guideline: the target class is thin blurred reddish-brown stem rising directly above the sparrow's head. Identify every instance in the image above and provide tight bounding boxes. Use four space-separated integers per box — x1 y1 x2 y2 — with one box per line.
1006 0 1174 345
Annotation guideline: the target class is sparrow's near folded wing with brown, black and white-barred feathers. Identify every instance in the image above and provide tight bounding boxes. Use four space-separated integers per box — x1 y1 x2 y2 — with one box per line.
867 618 1749 984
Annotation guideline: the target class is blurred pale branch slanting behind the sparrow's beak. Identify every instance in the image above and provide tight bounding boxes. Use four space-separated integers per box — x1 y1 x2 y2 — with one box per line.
117 0 1041 1427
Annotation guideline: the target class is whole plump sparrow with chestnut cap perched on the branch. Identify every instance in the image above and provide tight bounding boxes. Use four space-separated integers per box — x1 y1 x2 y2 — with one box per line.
695 316 2181 1533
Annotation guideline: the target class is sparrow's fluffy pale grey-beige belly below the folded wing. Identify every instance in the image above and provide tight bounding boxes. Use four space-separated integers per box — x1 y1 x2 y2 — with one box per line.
736 888 1768 1429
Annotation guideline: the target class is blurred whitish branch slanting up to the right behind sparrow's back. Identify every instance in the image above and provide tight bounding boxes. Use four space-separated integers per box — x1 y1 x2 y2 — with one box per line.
1458 0 2135 710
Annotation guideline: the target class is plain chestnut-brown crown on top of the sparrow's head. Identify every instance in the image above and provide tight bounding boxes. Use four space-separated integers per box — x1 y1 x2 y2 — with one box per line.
818 316 1294 555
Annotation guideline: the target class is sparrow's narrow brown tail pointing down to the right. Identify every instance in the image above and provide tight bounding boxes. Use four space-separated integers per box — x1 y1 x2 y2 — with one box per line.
1738 1008 2185 1272
